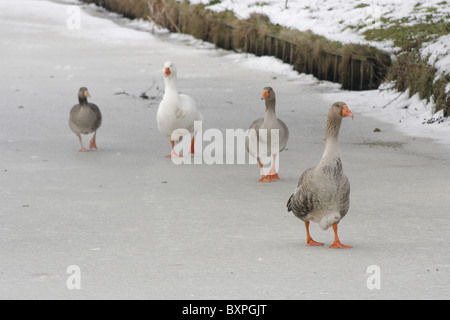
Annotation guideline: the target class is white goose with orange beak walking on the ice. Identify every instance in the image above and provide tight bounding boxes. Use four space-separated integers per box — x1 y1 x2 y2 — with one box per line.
156 61 203 158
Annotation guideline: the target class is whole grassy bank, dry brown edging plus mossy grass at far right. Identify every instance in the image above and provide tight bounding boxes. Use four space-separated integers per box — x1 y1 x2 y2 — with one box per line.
84 0 450 116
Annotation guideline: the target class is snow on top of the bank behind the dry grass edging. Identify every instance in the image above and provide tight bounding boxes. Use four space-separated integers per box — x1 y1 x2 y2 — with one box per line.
190 0 450 73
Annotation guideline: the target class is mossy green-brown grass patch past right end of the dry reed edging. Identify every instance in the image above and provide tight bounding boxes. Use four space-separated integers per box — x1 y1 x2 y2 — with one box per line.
356 1 450 117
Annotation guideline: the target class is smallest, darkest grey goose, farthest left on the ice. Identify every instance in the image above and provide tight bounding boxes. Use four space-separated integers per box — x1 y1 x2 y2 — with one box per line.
69 87 102 152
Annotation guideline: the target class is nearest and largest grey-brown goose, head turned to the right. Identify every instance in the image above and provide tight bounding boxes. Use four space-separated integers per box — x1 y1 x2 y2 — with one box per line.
287 102 353 248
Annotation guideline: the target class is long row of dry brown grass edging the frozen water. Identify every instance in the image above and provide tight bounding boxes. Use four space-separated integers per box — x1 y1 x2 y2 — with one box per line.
81 0 390 90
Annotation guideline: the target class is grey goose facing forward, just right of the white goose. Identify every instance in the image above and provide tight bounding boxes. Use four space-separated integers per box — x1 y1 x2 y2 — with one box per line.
246 87 289 182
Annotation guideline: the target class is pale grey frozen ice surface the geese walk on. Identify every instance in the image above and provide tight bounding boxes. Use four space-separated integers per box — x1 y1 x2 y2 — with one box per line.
0 0 450 299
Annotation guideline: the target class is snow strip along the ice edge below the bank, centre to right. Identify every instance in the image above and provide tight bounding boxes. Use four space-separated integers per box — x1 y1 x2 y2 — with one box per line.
224 54 450 148
